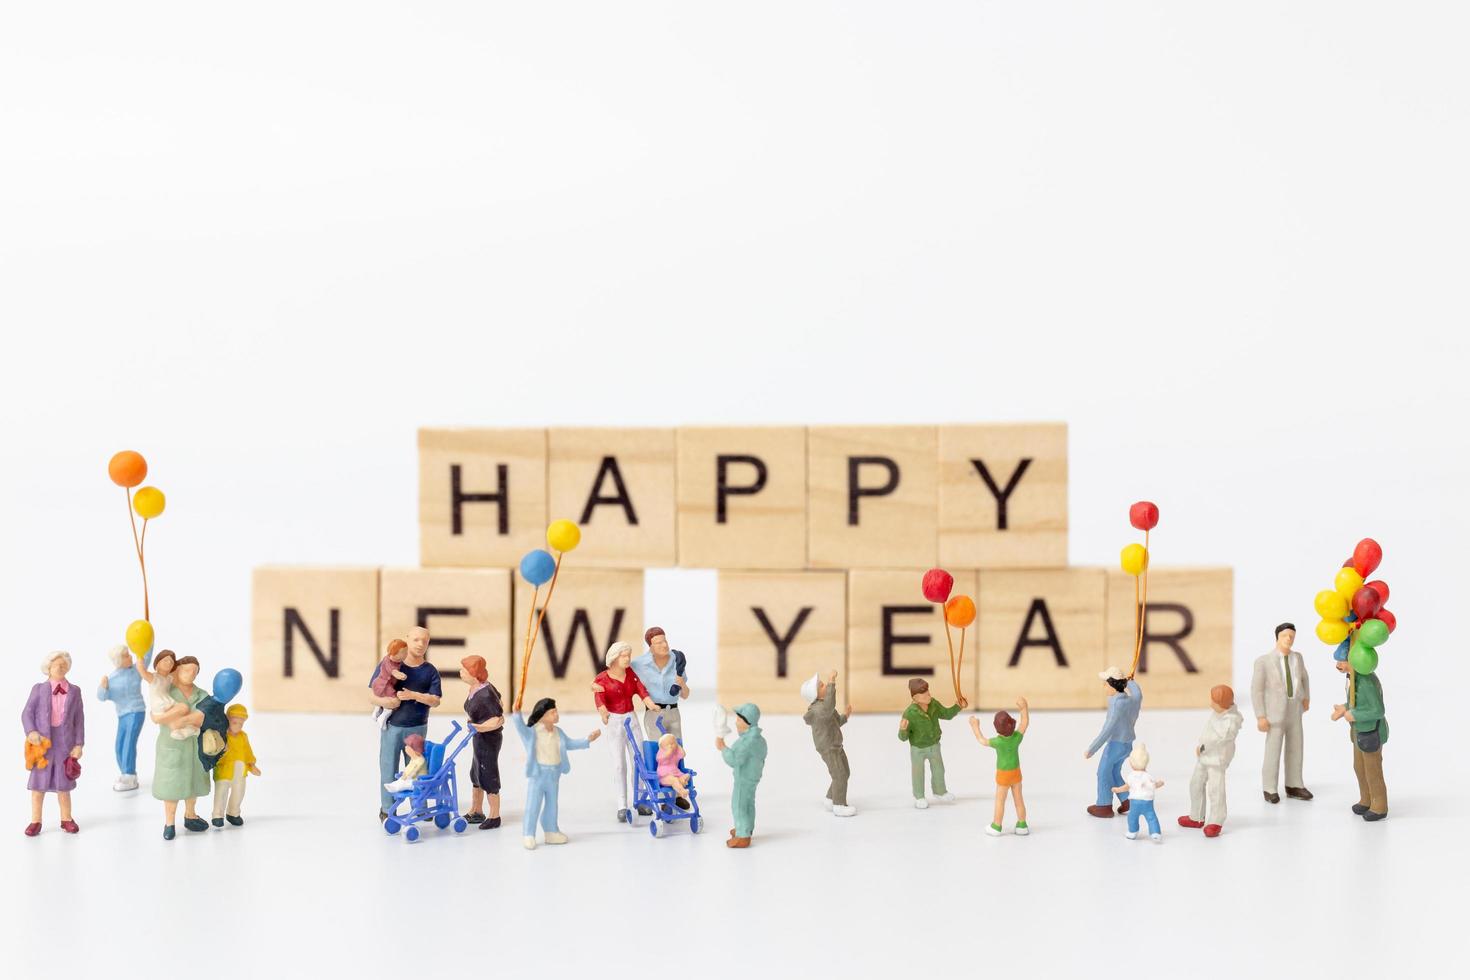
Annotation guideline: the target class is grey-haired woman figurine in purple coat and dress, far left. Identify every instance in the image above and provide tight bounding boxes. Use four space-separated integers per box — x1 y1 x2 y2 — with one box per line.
21 651 85 837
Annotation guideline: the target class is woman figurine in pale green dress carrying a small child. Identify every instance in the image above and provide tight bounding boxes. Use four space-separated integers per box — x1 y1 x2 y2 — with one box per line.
147 649 209 840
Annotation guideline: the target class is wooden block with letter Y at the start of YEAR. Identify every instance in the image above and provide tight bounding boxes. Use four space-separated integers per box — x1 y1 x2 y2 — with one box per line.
719 572 846 714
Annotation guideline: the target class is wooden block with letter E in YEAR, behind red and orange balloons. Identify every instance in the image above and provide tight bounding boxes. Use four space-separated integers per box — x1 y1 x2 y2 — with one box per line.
840 569 979 711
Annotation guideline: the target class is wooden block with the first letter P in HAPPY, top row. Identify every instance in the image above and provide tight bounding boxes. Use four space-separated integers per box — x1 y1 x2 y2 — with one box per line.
678 428 807 569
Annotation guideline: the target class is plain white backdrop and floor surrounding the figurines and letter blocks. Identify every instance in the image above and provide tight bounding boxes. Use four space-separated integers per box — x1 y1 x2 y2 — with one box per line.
0 0 1470 977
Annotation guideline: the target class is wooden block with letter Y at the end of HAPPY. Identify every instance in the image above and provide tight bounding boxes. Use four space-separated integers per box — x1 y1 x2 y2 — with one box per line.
939 423 1067 570
